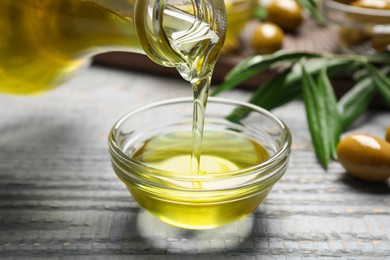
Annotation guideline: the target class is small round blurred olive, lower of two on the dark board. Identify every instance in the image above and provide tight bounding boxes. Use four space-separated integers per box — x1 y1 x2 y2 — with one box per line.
252 22 284 55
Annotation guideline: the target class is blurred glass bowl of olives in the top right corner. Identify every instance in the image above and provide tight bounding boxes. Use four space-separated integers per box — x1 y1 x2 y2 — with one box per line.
322 0 390 54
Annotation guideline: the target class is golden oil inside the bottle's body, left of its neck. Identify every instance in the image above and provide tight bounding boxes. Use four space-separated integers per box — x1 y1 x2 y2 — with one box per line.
0 0 141 94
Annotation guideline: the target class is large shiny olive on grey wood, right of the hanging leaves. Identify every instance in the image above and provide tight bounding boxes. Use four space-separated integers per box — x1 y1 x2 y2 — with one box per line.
337 134 390 181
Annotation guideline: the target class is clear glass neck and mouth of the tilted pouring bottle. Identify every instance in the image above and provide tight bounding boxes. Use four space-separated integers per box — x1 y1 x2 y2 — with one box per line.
134 0 226 70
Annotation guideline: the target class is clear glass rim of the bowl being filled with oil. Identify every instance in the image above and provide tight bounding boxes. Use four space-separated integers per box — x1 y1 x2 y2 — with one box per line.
109 97 292 181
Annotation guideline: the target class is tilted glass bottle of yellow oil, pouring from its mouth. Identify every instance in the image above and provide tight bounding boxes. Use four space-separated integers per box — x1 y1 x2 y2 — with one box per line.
0 0 226 94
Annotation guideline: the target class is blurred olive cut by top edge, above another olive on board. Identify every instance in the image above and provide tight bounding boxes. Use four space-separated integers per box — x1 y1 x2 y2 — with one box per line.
267 0 303 31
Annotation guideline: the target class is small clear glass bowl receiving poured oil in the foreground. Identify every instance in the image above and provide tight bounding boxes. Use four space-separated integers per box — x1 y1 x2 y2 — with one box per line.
109 98 291 229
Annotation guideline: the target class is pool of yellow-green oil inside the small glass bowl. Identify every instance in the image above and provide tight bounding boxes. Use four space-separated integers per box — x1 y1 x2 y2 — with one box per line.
124 131 270 229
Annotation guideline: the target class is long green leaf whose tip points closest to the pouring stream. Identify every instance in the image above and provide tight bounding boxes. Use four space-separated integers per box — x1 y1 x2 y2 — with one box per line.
211 51 320 96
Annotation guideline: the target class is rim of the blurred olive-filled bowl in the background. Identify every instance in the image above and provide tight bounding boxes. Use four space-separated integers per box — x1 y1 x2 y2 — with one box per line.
323 0 390 18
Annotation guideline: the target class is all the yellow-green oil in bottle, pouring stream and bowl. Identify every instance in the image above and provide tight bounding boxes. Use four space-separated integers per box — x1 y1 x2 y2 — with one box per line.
0 0 268 228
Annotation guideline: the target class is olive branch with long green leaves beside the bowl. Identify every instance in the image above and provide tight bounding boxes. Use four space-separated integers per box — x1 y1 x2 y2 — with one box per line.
212 51 390 169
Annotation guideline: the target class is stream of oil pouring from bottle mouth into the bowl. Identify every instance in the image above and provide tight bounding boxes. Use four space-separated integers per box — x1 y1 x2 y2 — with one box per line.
164 4 223 174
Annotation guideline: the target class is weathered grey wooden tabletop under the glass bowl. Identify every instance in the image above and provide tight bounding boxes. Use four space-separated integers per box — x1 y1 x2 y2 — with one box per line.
0 67 390 259
